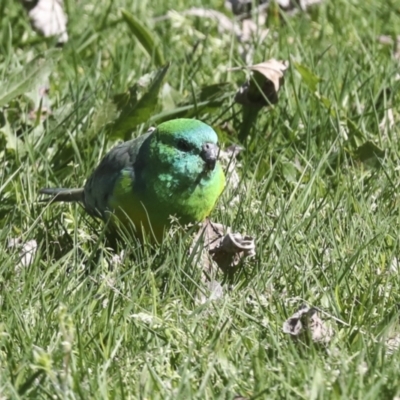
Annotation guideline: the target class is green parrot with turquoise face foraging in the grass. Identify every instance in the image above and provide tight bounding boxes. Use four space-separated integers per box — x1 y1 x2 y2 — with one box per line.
40 119 225 240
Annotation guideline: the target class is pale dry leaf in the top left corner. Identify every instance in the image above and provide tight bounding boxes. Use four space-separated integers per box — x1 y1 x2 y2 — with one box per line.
22 0 68 44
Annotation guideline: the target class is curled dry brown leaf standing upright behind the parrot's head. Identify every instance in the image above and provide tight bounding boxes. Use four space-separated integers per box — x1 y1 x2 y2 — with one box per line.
231 58 289 107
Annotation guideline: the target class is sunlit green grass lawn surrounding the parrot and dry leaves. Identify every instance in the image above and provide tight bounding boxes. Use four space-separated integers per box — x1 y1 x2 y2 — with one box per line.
0 0 400 400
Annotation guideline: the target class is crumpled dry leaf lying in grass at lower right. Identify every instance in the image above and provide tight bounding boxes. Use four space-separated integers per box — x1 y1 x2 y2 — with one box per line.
283 304 333 344
